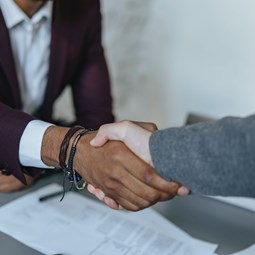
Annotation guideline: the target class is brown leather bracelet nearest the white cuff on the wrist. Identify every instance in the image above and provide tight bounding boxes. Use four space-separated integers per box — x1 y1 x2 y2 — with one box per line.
59 126 84 170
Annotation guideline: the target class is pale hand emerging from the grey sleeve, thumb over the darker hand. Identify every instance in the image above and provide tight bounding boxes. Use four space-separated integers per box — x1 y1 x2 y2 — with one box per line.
90 121 189 196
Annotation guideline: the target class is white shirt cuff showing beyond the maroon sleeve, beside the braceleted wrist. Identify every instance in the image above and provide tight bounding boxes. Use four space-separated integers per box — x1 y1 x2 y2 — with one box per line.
19 120 53 168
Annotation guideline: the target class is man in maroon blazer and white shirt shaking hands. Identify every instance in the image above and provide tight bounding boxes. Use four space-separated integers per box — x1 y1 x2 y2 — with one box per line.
0 0 178 210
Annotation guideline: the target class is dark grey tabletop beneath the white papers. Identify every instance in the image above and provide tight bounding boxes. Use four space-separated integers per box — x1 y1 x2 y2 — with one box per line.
0 174 255 255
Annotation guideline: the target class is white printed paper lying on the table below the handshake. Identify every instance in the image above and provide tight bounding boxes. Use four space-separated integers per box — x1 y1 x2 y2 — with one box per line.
0 184 217 255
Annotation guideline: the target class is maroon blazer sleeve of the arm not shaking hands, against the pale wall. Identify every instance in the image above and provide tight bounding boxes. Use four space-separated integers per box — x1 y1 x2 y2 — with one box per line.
72 1 114 129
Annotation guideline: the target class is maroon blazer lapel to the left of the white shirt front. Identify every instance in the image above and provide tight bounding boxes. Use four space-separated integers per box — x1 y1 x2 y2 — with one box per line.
0 10 22 108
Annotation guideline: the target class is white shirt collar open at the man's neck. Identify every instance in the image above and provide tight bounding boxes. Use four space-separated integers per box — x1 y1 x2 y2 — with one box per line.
0 0 53 29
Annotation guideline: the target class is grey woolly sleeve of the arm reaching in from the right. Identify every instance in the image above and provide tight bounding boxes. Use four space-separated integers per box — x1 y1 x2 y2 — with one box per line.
150 115 255 197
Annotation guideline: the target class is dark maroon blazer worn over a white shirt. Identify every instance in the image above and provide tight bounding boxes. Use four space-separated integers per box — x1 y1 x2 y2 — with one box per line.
0 0 114 182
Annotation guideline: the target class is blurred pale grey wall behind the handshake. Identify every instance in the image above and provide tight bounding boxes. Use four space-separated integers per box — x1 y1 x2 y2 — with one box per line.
52 0 255 128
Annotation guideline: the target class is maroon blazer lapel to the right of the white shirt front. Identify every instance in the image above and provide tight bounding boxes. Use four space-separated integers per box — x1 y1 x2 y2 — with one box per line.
42 1 71 116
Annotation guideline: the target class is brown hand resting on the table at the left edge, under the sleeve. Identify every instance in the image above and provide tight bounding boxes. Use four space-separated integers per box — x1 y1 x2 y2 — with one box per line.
0 172 34 192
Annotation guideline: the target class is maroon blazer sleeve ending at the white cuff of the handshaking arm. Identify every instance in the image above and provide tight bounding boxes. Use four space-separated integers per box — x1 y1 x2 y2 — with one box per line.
0 103 33 183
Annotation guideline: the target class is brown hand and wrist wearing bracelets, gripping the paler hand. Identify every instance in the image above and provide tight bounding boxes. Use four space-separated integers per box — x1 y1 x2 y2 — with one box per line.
42 126 180 211
